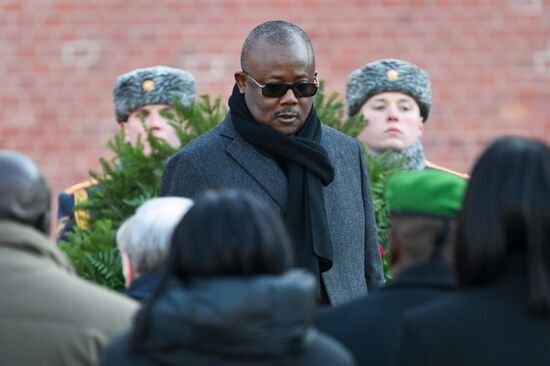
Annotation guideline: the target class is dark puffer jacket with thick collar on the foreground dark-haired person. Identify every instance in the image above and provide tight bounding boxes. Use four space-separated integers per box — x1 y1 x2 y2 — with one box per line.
101 270 354 366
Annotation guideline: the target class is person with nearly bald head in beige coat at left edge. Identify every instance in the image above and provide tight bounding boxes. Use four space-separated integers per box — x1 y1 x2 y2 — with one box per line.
0 150 138 365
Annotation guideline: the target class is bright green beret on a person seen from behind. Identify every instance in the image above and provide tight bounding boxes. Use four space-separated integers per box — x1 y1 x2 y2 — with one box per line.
385 169 466 218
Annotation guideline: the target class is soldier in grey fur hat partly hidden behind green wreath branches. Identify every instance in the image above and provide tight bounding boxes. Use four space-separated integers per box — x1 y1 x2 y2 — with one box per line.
57 66 196 240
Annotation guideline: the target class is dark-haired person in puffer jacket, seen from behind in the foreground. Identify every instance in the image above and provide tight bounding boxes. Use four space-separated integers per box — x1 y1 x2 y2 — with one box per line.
101 191 355 366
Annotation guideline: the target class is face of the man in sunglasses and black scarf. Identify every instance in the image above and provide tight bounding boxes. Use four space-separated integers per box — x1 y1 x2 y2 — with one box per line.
235 40 315 135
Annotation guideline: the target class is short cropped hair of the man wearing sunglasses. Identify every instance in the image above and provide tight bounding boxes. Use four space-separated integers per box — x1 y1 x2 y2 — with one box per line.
241 20 313 70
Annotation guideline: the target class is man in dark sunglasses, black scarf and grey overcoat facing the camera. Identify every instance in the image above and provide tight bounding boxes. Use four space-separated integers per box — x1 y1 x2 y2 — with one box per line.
160 21 384 305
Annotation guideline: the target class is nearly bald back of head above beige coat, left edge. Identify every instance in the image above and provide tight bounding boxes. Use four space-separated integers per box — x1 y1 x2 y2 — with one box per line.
0 150 51 235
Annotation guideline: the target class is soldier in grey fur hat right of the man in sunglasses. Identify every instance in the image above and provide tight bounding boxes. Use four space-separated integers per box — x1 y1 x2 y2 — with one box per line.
346 59 467 178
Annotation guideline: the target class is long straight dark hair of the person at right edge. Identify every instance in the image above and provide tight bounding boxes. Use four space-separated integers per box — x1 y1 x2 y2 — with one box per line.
455 137 550 314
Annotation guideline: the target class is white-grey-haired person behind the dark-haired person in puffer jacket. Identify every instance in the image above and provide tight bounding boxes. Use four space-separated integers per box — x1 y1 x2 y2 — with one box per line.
116 197 193 301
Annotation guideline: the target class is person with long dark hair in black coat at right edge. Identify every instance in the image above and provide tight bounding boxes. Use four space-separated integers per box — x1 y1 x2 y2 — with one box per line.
395 137 550 366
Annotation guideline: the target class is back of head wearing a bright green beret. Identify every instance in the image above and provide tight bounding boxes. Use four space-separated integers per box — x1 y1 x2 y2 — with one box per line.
385 170 466 269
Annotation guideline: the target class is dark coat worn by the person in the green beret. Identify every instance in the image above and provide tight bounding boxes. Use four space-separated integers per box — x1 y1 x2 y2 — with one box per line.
316 261 454 366
